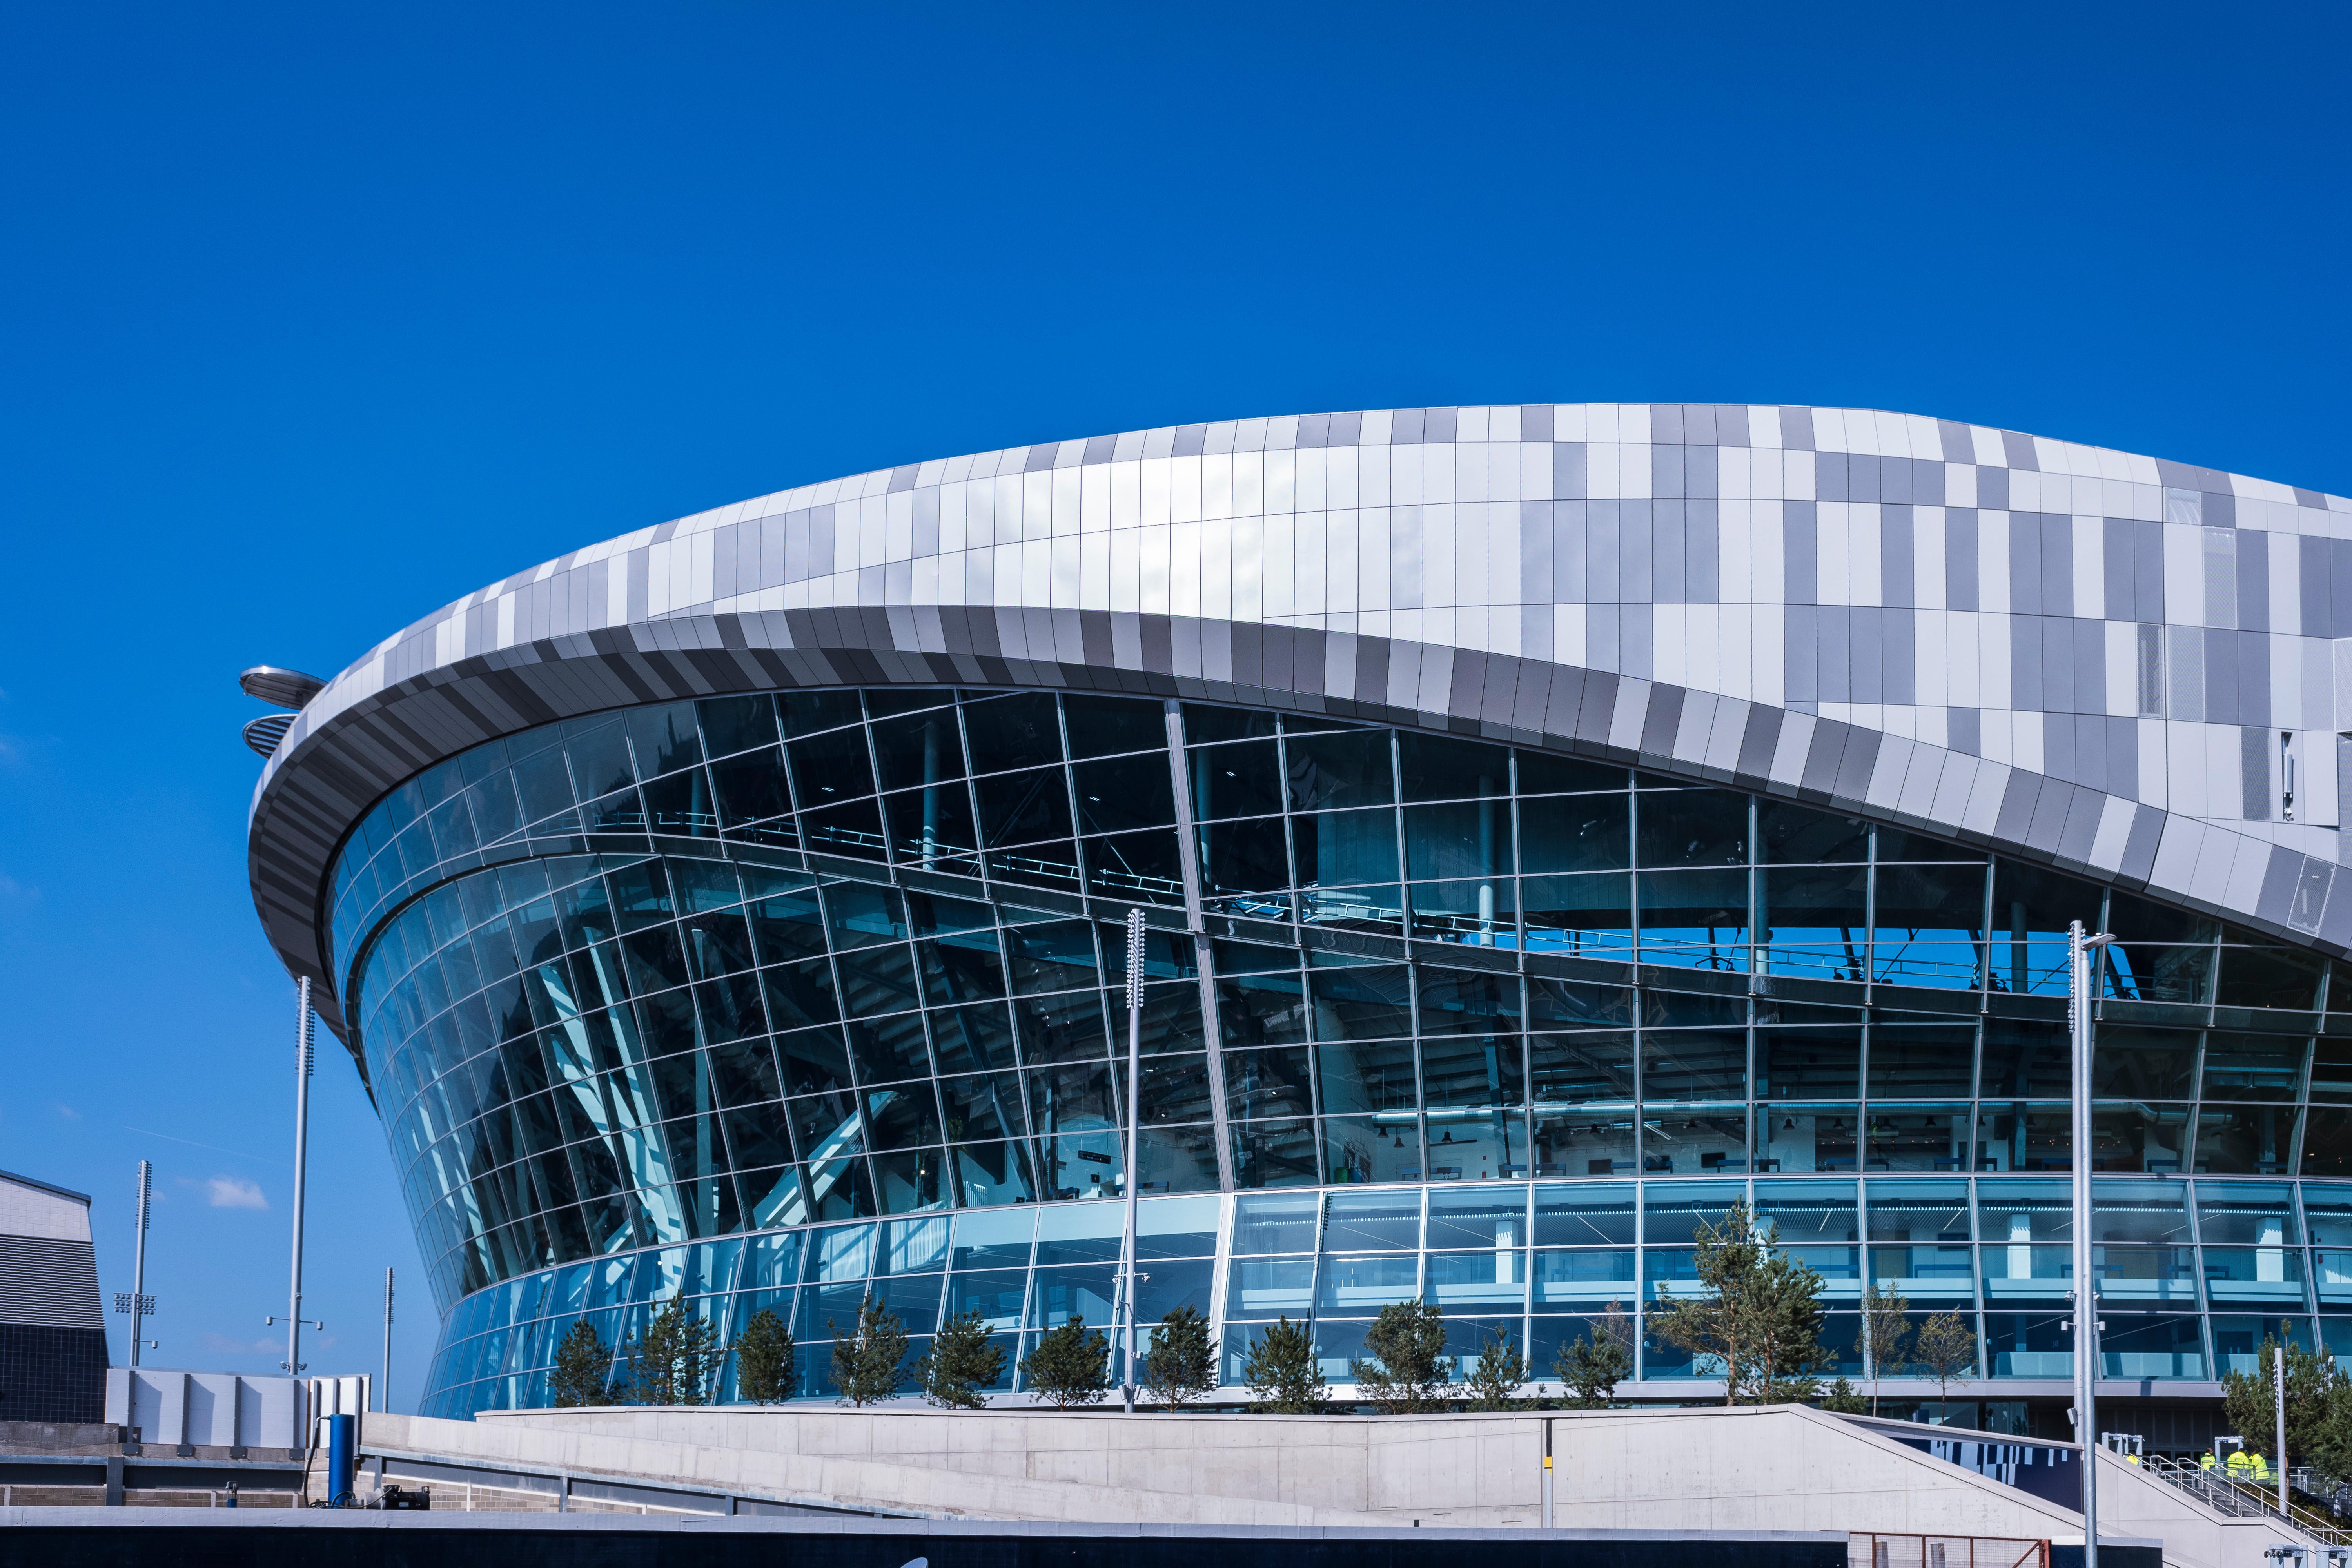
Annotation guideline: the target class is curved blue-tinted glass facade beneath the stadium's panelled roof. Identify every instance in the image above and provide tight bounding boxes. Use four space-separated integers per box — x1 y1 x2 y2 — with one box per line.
332 689 2352 1415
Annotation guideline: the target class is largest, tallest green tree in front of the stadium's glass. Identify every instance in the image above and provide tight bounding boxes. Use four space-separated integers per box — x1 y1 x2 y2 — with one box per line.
1651 1199 1825 1406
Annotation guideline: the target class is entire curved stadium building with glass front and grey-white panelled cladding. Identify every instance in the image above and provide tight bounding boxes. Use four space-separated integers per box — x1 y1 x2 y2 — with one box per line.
247 404 2352 1448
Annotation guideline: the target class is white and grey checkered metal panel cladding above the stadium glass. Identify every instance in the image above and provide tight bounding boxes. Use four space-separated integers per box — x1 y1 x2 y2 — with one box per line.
252 404 2352 1034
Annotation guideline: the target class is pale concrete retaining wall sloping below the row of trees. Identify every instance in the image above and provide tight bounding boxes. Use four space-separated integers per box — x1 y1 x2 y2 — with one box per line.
362 1406 2305 1568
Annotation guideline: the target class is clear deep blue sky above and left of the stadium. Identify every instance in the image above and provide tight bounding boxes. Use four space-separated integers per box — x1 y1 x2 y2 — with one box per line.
0 0 2352 1408
